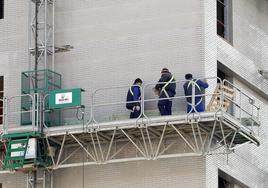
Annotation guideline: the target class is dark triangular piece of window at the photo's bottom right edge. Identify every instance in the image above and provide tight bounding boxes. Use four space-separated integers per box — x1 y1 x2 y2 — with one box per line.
218 170 249 188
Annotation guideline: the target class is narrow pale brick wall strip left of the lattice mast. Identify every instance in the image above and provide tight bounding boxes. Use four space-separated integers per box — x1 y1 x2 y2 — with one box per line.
0 0 28 127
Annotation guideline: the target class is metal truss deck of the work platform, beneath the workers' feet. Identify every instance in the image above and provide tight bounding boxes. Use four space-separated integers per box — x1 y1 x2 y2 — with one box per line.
2 111 260 169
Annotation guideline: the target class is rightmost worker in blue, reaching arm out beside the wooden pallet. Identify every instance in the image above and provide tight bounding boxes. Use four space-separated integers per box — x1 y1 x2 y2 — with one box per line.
183 73 208 113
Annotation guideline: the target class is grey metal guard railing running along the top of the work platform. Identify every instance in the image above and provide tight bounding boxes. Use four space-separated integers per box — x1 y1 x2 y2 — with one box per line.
2 77 260 134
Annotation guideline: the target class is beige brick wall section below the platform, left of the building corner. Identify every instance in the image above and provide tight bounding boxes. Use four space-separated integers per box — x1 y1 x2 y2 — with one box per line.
54 157 205 188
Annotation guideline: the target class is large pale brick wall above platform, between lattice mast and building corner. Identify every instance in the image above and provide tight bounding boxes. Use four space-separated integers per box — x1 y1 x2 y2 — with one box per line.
55 0 205 119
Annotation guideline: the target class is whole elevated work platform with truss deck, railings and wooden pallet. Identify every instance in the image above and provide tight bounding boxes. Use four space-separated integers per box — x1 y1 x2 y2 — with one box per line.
0 77 260 169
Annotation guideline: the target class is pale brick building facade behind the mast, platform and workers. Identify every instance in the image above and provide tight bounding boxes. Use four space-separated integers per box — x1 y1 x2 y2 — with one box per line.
0 0 268 188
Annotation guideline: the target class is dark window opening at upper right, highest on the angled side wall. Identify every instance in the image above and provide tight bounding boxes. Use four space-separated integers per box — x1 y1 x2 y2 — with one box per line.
216 0 233 43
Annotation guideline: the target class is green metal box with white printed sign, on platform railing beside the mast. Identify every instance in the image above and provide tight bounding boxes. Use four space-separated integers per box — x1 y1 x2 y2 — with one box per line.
49 88 83 109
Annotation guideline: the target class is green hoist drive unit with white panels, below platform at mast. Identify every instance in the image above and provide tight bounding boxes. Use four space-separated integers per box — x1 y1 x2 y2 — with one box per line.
3 132 51 171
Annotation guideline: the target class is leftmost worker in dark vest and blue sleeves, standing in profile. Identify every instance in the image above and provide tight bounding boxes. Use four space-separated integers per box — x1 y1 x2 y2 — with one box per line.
126 78 142 118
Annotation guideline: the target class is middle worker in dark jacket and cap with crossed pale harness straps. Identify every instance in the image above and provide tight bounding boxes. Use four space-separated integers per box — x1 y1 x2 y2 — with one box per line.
154 68 176 116
